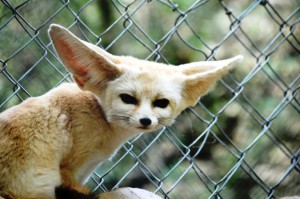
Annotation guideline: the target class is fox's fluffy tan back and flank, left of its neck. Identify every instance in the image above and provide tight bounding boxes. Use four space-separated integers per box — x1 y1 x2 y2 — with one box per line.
0 84 97 197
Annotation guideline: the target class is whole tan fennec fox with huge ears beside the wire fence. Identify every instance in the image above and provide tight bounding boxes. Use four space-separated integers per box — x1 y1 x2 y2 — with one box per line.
0 25 242 199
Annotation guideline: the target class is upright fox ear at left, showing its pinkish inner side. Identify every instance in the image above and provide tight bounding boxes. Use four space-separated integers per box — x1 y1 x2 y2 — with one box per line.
49 24 121 90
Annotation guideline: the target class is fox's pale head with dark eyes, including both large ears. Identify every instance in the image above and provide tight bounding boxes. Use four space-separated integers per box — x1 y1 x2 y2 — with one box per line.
49 25 242 132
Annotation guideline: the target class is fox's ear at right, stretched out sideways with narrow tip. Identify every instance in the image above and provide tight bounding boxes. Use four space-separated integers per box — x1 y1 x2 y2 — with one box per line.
179 55 243 106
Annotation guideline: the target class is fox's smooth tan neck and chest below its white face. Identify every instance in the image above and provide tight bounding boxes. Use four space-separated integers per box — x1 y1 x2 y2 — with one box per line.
56 88 141 183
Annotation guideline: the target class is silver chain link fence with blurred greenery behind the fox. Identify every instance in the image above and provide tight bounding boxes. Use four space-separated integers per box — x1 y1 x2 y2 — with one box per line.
0 0 300 199
